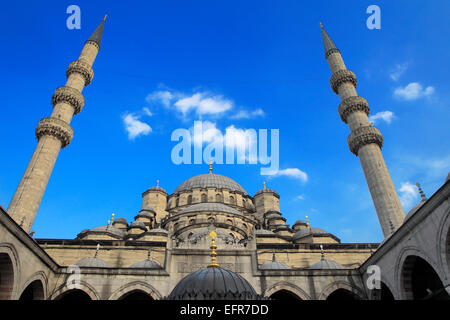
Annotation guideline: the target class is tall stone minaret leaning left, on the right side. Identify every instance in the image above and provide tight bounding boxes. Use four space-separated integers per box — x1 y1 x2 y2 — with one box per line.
320 23 405 237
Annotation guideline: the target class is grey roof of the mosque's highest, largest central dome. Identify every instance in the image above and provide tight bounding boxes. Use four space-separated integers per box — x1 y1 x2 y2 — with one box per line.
174 173 247 195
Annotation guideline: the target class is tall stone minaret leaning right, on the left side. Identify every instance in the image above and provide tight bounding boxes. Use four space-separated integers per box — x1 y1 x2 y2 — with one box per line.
8 16 106 232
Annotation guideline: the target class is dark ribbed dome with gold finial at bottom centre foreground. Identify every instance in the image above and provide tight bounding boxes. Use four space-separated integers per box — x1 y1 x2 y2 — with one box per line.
168 267 260 300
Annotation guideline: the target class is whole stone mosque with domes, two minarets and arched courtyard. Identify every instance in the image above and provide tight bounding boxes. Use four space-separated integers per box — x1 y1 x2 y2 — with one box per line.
0 16 450 300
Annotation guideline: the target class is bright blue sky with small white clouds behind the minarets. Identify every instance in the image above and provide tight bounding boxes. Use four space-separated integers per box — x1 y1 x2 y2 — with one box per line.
0 1 450 242
